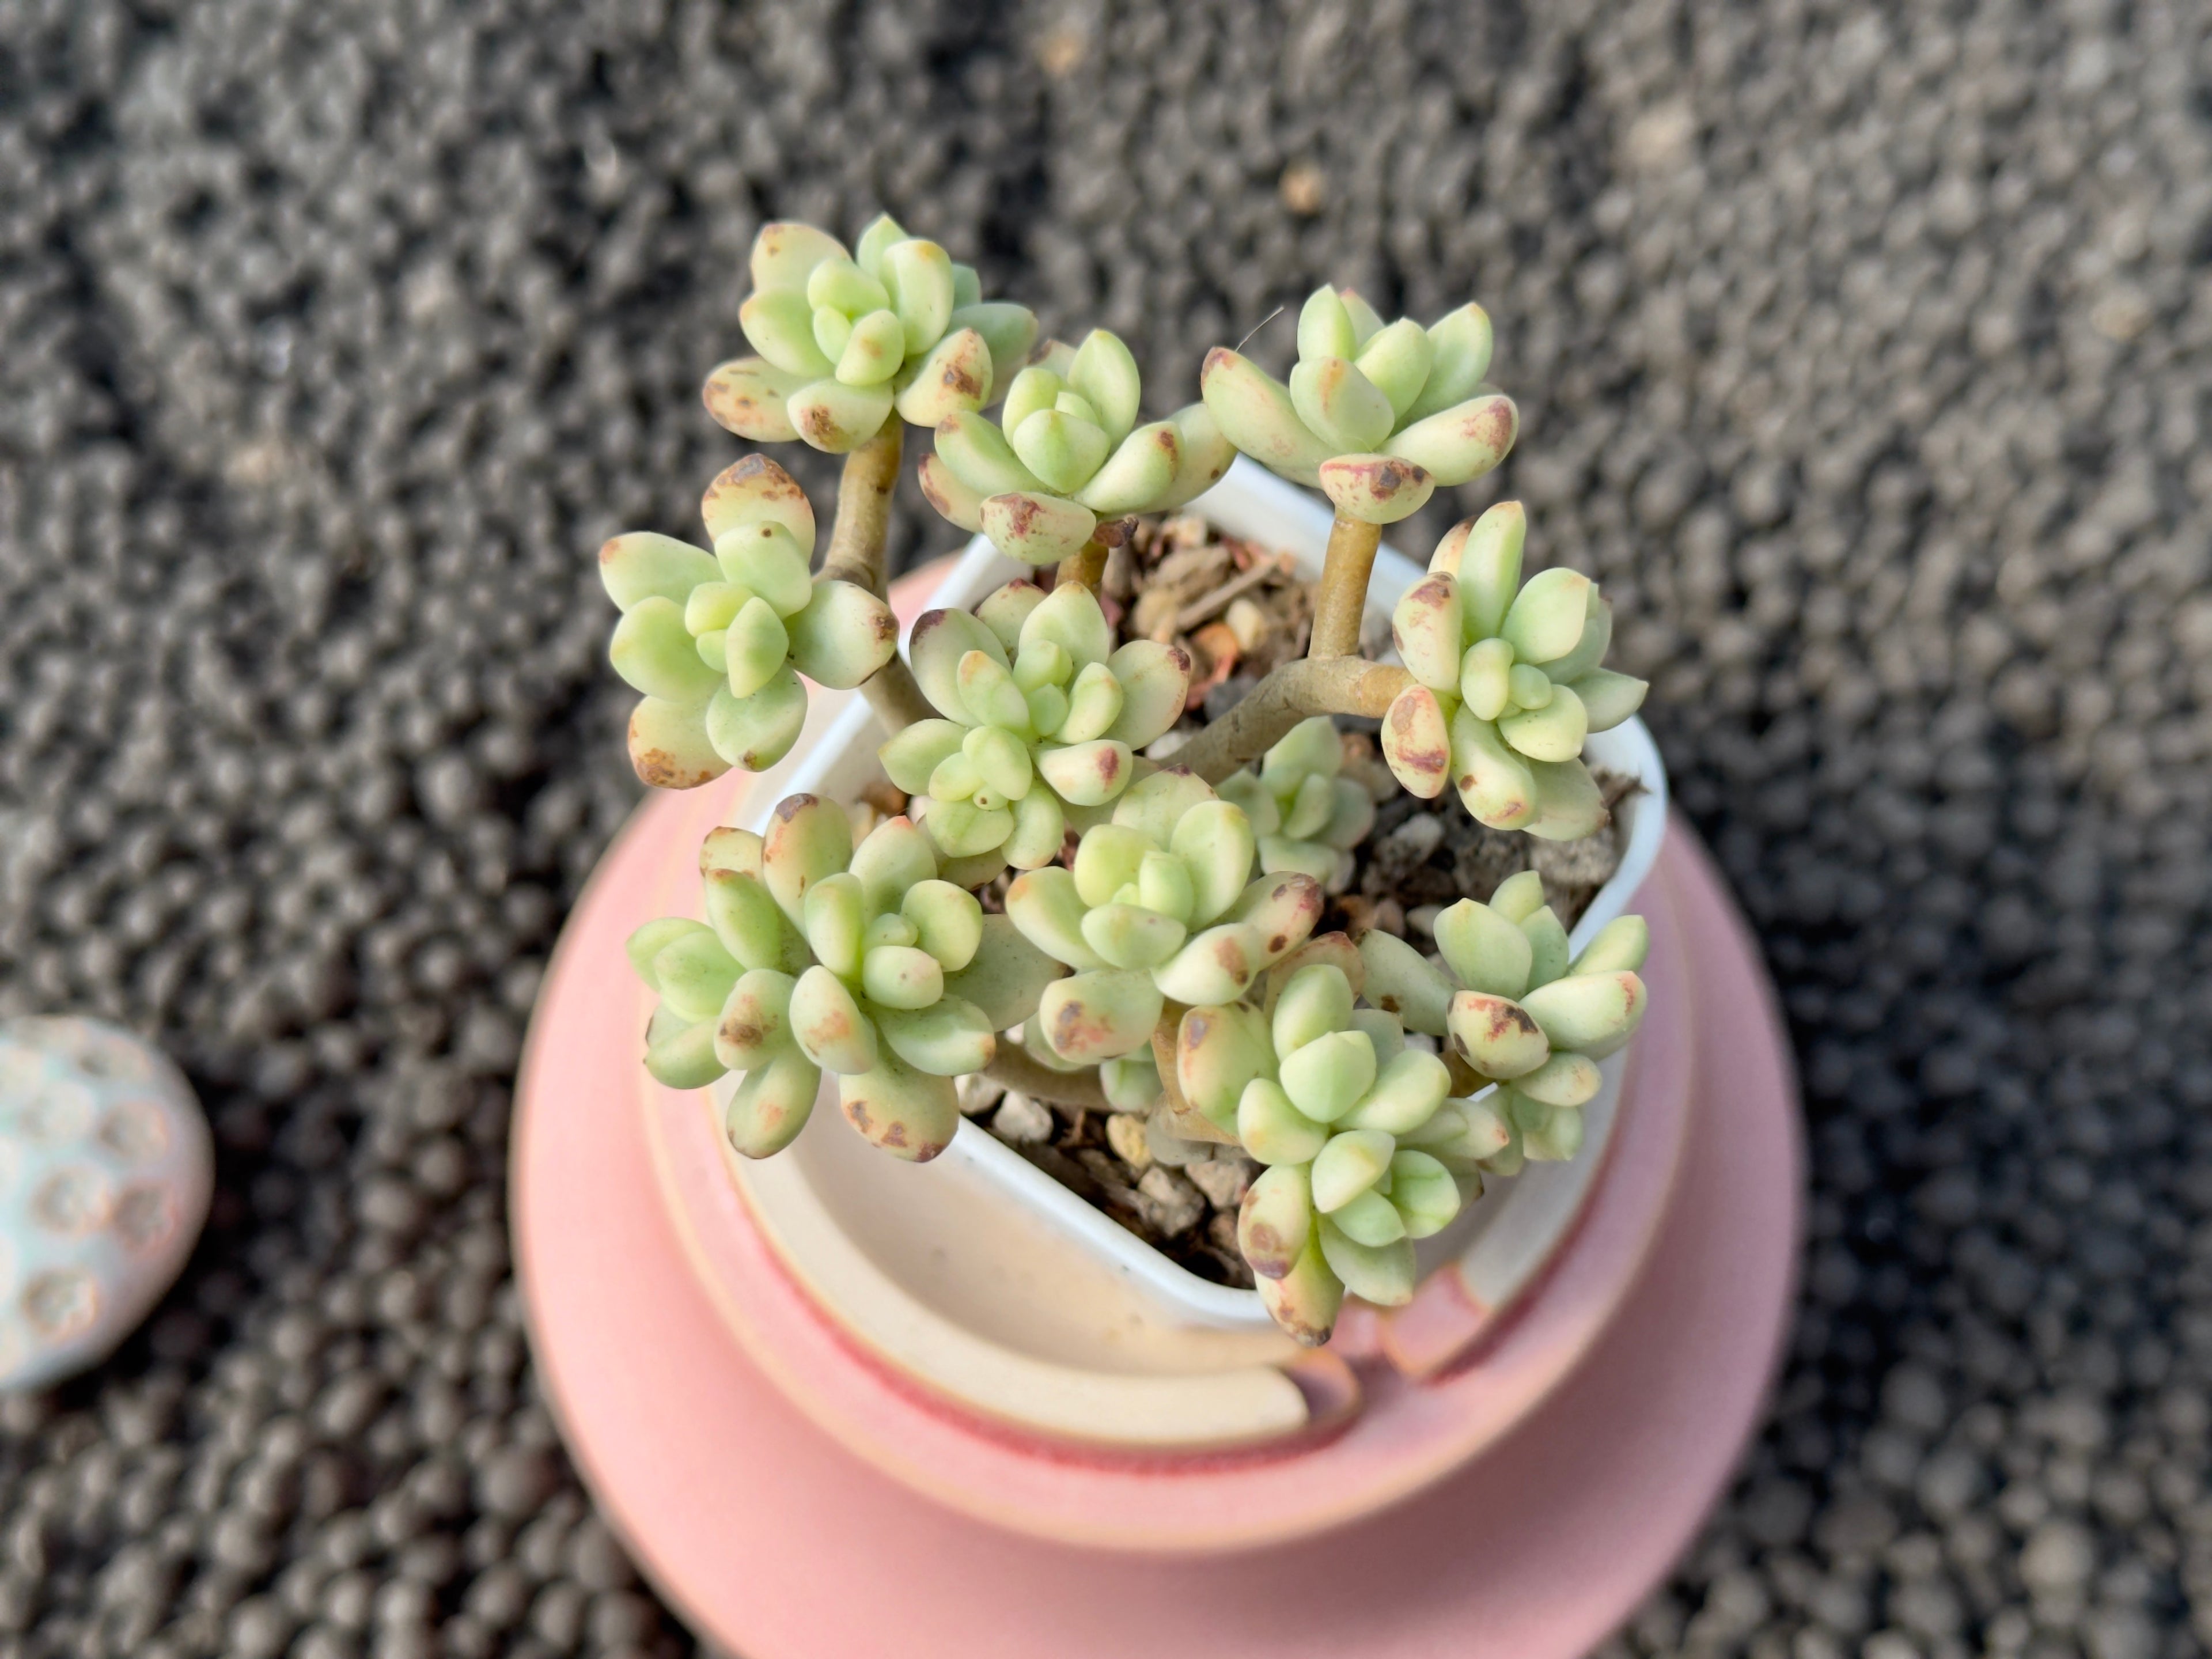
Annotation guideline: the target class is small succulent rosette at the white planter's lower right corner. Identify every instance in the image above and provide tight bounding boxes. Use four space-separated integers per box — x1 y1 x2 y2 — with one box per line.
1361 869 1650 1175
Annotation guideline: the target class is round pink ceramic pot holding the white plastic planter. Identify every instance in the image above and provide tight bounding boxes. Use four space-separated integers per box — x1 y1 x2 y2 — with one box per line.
513 473 1801 1659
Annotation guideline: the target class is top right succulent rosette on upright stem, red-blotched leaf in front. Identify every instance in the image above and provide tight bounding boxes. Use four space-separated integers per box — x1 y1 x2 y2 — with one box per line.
1199 287 1520 524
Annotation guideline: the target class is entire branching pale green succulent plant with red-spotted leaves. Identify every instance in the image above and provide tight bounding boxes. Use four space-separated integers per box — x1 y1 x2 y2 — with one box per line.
601 243 1648 1343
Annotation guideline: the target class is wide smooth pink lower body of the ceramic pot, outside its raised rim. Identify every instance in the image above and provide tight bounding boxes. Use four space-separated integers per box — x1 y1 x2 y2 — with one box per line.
511 770 1801 1659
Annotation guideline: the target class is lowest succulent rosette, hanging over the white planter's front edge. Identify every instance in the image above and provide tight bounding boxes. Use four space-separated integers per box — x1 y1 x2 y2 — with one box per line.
1175 960 1509 1343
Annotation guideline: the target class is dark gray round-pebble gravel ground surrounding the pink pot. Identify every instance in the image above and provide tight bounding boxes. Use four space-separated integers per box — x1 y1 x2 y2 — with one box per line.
0 0 2212 1659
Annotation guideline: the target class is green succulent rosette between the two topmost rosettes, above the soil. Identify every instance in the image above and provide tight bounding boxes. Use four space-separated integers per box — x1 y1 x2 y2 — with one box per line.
920 327 1234 564
